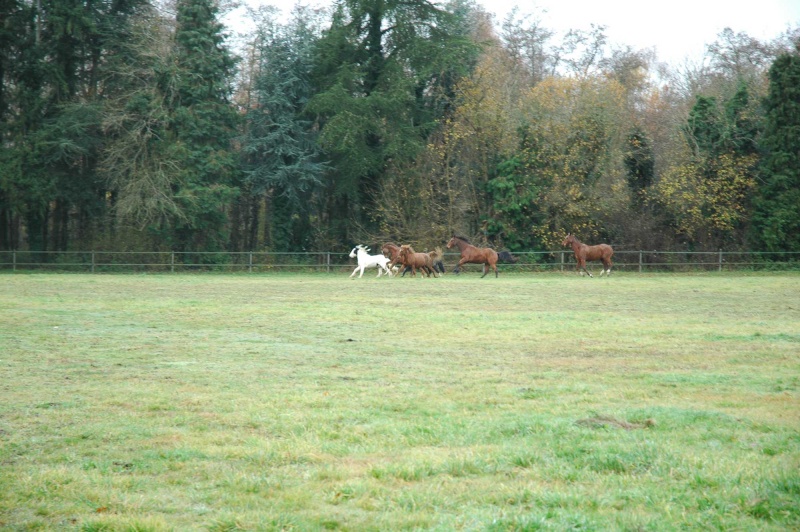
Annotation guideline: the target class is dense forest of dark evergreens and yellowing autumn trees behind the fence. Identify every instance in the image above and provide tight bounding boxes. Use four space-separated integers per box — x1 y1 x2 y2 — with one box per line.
0 0 800 252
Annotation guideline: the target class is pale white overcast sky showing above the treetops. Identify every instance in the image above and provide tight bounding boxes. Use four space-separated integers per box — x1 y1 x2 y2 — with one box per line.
224 0 800 64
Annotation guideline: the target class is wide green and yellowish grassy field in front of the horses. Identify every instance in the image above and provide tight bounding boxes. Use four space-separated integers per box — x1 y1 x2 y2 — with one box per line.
0 270 800 531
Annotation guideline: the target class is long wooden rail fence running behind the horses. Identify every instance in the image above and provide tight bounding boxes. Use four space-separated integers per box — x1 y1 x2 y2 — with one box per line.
0 250 800 273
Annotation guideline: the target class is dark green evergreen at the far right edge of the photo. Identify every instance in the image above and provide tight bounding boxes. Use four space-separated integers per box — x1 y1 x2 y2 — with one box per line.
753 46 800 252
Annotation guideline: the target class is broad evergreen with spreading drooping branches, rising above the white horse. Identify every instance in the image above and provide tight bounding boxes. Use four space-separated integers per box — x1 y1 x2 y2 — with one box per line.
309 0 477 240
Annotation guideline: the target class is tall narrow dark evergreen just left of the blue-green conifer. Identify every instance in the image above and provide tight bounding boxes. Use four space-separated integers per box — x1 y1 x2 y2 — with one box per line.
165 0 240 250
